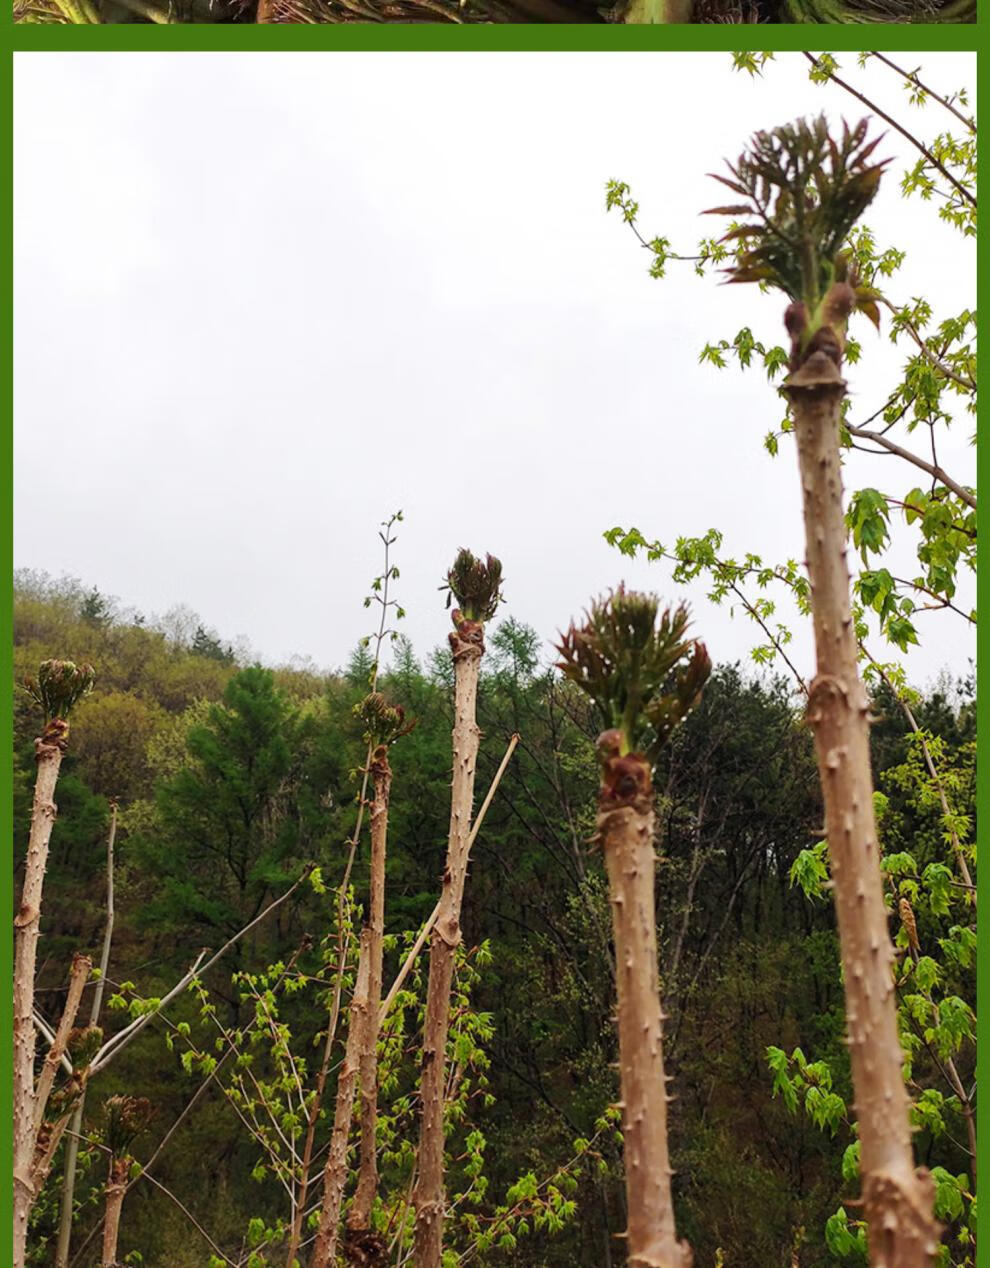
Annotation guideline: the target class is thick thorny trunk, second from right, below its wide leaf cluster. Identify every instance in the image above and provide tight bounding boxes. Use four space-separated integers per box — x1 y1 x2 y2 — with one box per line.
597 732 692 1268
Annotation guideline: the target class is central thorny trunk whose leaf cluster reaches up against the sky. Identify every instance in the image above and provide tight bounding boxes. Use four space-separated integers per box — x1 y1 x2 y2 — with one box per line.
413 619 484 1268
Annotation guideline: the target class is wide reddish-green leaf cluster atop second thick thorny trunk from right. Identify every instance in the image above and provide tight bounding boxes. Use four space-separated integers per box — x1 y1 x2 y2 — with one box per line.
556 586 711 756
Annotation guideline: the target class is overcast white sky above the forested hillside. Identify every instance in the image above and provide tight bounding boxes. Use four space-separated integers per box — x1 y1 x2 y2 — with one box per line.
15 52 975 683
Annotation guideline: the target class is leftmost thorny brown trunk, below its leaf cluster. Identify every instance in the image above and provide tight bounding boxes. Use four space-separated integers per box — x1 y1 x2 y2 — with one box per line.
14 718 68 1268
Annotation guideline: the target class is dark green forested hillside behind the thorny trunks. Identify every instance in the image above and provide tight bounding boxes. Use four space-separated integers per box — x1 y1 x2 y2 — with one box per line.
14 574 975 1268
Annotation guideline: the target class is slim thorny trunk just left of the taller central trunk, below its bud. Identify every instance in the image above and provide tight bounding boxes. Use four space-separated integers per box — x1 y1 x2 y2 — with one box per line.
347 744 392 1247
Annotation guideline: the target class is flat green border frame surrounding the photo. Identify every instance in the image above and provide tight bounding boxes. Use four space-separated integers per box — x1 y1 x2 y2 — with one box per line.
0 29 990 1268
